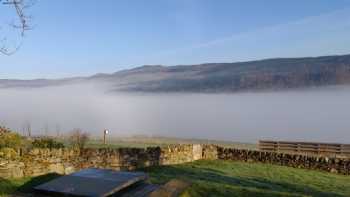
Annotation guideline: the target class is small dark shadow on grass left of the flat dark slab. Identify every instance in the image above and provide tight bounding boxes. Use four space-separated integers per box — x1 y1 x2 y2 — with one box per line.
17 173 62 193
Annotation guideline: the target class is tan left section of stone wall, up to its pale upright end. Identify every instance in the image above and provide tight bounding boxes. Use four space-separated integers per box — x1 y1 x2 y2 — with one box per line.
0 144 202 178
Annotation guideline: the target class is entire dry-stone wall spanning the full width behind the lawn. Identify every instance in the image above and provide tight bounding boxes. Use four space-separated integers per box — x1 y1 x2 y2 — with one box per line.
0 144 350 178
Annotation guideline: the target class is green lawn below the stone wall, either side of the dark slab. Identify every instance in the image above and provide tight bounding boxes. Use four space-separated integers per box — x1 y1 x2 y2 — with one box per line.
0 161 350 197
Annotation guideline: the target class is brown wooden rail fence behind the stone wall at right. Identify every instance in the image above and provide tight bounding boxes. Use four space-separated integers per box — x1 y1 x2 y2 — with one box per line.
259 140 350 157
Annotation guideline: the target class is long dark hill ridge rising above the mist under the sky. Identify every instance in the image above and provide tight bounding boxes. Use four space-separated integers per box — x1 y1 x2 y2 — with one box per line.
0 55 350 92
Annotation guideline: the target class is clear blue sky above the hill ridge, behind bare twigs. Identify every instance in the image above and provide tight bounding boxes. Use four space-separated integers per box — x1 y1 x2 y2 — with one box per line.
0 0 350 79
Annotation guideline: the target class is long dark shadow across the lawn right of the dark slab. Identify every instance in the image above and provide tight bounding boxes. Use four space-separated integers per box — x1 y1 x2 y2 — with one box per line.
142 166 344 197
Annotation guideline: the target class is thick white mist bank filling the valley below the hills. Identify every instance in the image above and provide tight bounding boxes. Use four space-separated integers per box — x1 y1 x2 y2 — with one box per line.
0 85 350 143
